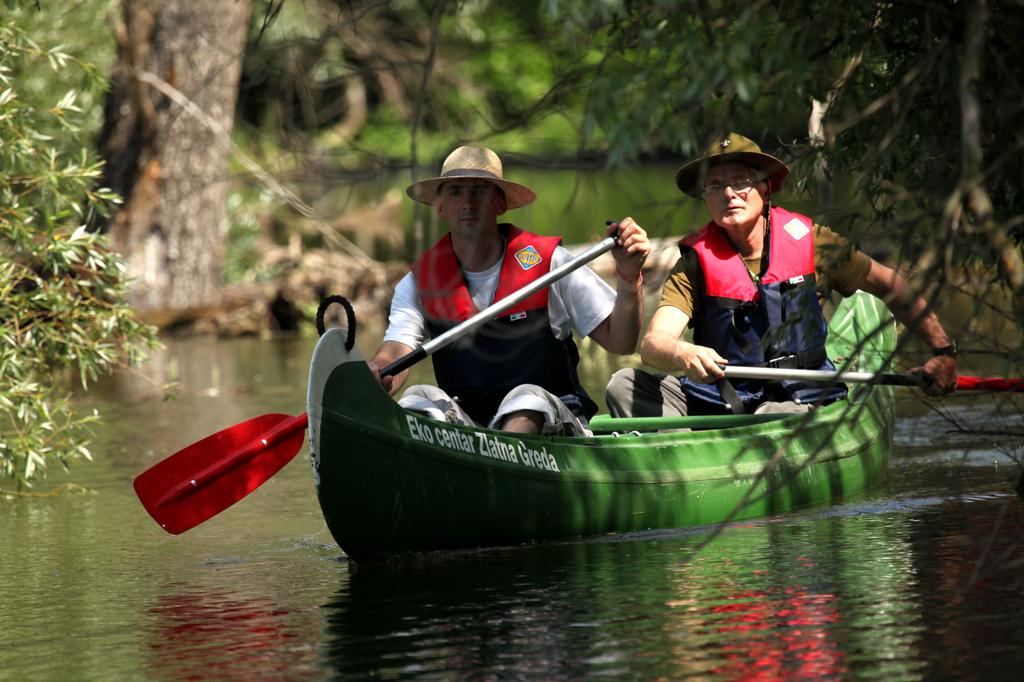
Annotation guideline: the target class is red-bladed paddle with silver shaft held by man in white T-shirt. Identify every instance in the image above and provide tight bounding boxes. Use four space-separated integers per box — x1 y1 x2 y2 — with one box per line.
134 237 615 535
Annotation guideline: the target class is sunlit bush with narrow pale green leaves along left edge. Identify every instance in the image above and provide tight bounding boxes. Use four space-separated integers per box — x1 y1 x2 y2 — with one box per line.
0 9 156 484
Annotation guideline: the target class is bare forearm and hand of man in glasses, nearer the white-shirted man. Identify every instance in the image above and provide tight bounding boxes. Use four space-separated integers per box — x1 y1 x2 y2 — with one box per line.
640 305 728 384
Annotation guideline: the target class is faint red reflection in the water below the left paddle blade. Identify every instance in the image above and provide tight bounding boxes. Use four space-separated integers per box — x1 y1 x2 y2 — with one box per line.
148 592 299 680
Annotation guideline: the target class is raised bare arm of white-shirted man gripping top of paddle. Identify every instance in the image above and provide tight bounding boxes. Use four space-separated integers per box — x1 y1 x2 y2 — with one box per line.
590 218 650 355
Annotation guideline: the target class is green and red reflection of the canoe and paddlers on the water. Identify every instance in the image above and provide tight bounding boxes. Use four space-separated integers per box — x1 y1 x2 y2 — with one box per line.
325 509 920 679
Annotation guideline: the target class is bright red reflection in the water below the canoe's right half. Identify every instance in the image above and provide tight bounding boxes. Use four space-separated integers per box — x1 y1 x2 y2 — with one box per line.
711 587 847 680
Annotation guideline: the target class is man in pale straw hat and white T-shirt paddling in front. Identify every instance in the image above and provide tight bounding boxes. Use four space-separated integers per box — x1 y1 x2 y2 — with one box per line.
370 146 650 434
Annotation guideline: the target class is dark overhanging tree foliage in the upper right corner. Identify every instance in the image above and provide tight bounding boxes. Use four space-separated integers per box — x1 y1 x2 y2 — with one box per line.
549 0 1024 260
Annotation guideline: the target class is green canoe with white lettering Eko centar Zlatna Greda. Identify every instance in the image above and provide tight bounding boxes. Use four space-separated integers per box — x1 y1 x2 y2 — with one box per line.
308 293 895 562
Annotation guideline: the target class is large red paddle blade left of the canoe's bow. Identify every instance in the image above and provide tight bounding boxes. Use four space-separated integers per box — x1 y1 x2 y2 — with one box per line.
135 413 306 535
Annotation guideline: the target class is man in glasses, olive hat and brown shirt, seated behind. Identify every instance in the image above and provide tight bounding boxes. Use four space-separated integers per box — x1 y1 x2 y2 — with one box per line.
605 133 957 417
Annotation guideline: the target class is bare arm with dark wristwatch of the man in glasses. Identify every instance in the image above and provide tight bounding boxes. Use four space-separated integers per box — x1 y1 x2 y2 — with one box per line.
862 259 956 395
